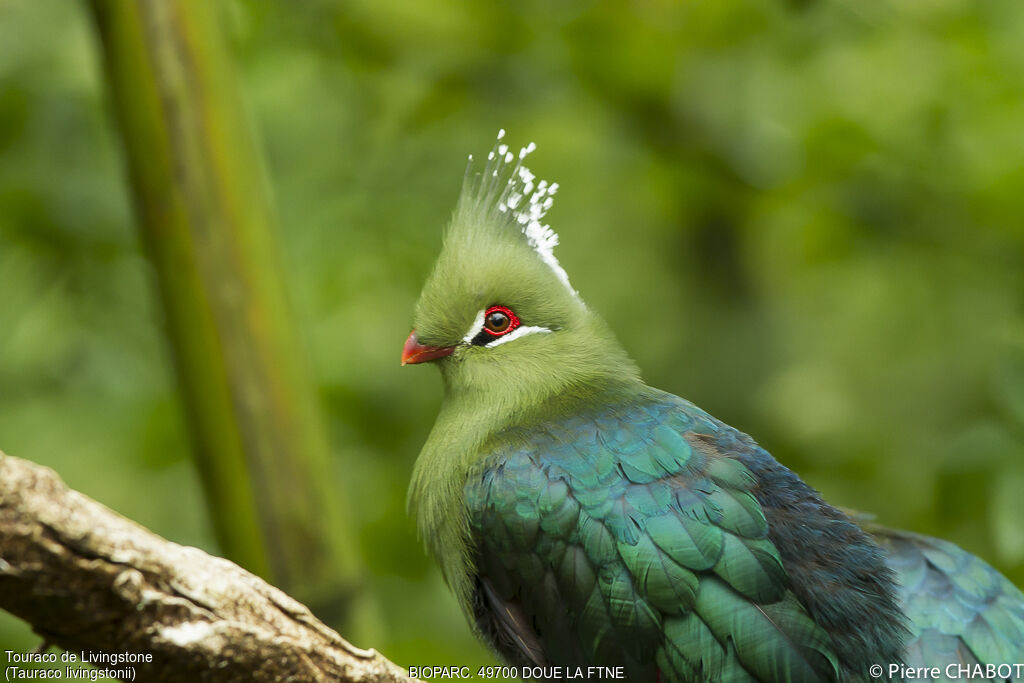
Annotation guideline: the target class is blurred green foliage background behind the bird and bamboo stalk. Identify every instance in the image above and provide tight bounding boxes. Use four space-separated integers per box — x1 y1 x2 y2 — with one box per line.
0 0 1024 666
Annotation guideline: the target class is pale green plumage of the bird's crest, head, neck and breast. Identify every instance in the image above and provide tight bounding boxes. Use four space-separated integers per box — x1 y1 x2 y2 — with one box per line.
410 131 642 606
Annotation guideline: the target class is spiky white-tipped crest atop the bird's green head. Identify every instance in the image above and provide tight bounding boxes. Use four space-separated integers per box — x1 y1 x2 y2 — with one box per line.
459 128 579 297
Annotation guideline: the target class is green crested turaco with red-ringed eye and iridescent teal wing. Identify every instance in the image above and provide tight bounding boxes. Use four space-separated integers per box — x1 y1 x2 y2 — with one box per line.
401 129 1024 683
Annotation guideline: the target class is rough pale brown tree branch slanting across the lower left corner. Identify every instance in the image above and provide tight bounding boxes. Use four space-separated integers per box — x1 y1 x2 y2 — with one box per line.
0 453 412 682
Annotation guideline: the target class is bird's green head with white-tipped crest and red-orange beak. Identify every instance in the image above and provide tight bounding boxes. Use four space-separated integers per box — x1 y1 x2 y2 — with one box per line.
401 131 635 403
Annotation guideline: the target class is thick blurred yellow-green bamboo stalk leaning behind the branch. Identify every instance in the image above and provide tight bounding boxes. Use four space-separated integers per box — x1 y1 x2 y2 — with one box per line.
90 0 356 622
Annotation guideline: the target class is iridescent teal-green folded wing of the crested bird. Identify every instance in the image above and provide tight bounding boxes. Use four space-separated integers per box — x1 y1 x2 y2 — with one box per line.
466 397 838 682
